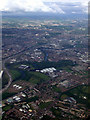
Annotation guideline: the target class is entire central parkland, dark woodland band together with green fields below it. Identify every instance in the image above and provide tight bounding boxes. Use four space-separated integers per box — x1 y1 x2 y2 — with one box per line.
6 60 76 84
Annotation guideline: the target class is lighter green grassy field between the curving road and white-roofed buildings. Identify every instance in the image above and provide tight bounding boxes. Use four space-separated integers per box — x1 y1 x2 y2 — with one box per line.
10 70 50 84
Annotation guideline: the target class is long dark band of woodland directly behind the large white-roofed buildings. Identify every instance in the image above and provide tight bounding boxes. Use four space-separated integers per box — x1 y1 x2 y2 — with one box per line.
6 60 77 70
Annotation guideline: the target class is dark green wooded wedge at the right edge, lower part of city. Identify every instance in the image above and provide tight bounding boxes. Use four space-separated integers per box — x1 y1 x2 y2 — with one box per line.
60 85 90 108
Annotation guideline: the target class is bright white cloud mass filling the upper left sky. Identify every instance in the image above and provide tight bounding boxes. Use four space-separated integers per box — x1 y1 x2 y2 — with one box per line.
0 0 64 13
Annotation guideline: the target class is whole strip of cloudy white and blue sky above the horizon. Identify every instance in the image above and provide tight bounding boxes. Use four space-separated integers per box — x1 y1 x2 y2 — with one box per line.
0 0 89 14
